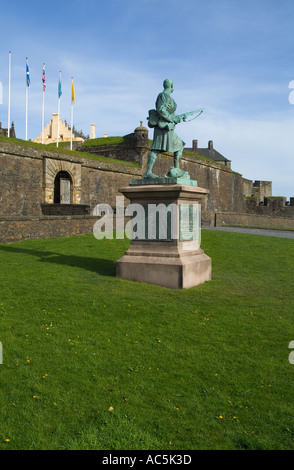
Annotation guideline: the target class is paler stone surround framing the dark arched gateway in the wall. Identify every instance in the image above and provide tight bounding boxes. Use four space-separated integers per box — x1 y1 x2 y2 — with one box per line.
43 157 82 204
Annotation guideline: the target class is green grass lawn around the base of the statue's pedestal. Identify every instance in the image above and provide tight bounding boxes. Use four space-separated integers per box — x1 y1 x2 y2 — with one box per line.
0 230 294 450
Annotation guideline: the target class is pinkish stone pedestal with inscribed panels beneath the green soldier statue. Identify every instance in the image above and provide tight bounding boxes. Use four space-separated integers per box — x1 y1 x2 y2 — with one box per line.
116 178 211 289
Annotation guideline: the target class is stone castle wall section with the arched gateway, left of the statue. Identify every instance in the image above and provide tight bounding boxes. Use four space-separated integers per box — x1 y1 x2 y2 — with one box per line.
0 142 141 243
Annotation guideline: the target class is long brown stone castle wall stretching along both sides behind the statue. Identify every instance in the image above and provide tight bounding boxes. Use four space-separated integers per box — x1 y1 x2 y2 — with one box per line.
0 130 294 242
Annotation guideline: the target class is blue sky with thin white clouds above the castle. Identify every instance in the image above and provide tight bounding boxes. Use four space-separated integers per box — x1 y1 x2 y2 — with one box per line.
0 0 294 198
